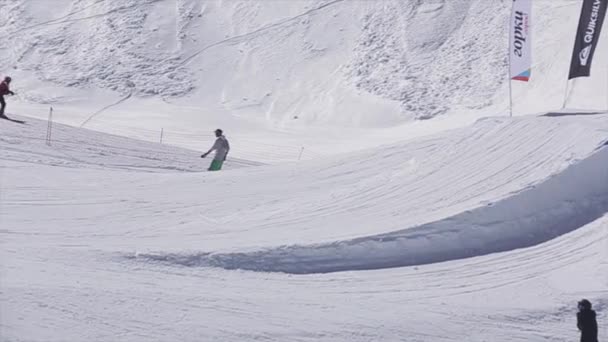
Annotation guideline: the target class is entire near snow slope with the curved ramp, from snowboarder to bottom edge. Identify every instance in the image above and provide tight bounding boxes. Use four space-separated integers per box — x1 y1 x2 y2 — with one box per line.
0 115 608 341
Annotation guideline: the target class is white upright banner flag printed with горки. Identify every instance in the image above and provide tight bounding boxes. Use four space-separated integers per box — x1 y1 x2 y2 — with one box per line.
509 0 532 82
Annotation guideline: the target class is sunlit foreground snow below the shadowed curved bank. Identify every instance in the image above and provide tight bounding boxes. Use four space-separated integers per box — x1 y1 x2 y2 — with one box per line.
0 217 608 342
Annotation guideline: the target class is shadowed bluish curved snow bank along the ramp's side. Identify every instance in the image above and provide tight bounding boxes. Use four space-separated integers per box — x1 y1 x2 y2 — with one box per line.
133 119 608 273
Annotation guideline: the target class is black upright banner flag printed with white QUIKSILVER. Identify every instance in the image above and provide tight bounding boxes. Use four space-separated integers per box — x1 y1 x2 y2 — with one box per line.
568 0 608 80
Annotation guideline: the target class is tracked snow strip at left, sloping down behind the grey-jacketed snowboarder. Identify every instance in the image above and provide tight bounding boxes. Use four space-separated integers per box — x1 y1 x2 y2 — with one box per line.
0 117 261 172
